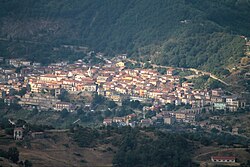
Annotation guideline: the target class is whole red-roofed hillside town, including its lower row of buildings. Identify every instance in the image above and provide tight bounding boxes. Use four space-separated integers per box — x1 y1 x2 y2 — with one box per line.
0 55 248 127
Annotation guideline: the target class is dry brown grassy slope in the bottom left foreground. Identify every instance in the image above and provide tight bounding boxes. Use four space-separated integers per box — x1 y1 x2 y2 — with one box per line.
0 129 114 167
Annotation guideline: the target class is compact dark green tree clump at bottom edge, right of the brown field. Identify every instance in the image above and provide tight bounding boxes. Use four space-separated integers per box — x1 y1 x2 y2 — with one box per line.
113 129 192 167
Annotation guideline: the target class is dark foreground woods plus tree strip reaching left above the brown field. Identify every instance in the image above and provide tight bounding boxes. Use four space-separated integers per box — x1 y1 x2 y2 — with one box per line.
72 127 195 167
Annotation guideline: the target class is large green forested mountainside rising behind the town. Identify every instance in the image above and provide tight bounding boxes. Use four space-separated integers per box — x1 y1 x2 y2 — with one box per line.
0 0 250 73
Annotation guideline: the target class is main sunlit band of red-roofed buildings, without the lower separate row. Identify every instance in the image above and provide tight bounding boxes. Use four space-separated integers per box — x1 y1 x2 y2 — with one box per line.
0 58 246 115
